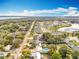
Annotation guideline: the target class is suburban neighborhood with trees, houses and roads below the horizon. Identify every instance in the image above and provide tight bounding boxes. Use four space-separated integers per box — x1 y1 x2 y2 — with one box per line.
0 18 79 59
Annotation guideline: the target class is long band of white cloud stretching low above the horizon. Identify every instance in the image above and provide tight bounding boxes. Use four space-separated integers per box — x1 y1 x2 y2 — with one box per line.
0 7 79 16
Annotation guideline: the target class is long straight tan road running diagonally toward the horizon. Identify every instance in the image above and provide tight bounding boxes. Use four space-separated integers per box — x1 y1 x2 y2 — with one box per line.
14 21 35 59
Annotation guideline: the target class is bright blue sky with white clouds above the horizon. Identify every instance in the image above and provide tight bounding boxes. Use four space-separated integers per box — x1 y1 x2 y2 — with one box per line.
0 0 79 16
